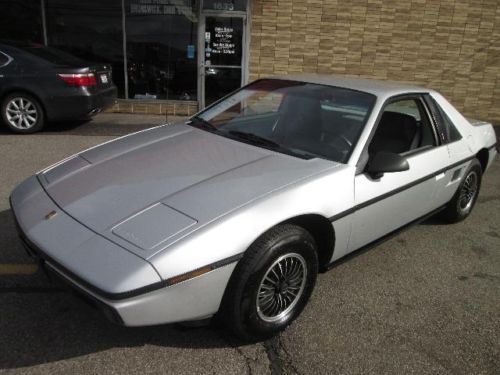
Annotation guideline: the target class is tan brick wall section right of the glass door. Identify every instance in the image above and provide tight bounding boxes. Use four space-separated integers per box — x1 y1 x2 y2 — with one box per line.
250 0 500 124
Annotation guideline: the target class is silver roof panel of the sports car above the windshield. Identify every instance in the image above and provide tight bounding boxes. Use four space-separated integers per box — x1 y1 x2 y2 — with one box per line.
270 74 432 97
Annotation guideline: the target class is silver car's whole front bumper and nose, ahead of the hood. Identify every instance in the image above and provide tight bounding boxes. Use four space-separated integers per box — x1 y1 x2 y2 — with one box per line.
11 177 236 326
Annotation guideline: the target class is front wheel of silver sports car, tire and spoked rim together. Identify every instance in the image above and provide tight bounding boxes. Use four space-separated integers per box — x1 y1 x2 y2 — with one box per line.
218 224 318 341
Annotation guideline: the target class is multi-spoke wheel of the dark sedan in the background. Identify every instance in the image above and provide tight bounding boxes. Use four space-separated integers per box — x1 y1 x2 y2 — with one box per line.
2 93 45 133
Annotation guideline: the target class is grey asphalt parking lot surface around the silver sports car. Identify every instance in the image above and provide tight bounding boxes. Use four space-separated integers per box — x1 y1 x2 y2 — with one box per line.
0 114 500 374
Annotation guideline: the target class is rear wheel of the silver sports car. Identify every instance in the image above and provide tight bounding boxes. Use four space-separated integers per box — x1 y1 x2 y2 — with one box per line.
443 159 482 223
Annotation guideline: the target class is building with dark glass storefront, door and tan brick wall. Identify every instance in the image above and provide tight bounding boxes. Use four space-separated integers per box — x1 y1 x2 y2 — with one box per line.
0 0 500 123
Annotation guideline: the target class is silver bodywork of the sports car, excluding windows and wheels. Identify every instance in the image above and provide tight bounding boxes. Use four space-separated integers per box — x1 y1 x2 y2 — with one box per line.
11 75 496 325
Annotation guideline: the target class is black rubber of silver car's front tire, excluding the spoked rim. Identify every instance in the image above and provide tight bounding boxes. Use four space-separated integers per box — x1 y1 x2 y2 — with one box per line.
225 225 318 340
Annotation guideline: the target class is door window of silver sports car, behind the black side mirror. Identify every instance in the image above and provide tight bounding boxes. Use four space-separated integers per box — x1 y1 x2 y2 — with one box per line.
368 98 436 155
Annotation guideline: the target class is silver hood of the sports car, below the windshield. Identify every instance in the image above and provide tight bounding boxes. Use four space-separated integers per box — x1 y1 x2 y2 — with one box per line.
39 124 337 259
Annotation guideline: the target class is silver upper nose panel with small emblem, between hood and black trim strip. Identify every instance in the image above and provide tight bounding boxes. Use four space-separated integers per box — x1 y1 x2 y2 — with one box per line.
11 176 161 294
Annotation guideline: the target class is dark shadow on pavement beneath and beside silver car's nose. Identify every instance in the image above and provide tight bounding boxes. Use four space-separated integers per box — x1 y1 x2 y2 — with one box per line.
0 210 234 369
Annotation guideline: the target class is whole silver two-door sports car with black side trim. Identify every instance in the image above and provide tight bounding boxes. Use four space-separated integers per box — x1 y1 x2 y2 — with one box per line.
11 75 497 339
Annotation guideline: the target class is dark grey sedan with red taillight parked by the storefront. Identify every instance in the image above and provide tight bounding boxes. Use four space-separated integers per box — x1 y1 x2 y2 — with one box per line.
0 43 116 133
